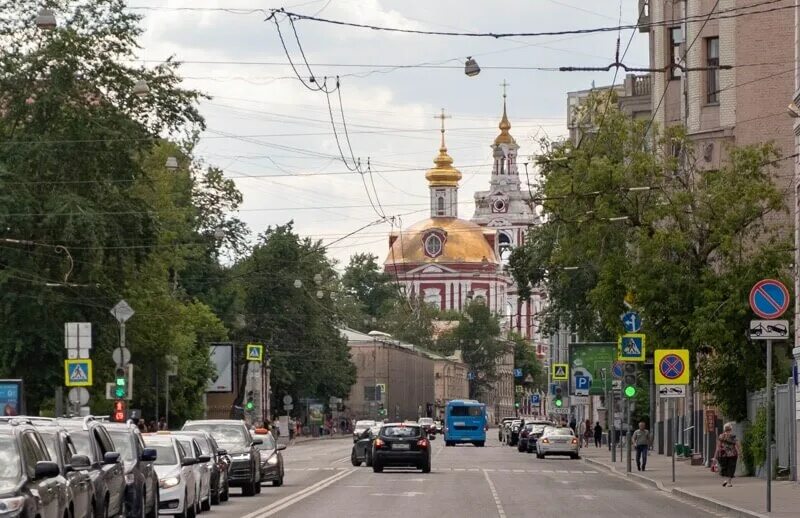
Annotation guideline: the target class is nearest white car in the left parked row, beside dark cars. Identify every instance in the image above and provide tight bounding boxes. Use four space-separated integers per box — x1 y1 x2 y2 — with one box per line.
144 435 198 518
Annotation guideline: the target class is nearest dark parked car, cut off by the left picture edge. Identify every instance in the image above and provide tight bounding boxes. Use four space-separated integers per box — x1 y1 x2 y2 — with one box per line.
0 420 69 518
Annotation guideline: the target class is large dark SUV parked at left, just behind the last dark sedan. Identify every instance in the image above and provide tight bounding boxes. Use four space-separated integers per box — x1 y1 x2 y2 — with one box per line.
182 419 262 496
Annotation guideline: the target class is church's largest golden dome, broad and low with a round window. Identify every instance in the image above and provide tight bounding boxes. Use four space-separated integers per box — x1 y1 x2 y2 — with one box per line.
384 217 499 265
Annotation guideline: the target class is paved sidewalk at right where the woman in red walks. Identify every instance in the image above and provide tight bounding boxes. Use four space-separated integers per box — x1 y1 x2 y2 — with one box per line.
581 447 800 518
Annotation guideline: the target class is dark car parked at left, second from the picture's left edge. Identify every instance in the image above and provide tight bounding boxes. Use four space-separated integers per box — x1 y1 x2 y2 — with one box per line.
34 422 95 518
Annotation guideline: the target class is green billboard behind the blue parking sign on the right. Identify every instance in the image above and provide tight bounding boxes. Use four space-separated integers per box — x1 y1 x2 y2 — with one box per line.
569 342 617 396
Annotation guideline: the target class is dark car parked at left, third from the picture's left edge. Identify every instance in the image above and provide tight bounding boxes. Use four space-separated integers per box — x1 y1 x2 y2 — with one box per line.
56 416 125 516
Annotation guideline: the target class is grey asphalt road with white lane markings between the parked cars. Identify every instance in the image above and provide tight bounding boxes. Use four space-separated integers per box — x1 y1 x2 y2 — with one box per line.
192 434 718 518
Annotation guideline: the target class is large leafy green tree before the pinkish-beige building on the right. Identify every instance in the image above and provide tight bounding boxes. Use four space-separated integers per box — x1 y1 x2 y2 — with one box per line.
511 93 791 419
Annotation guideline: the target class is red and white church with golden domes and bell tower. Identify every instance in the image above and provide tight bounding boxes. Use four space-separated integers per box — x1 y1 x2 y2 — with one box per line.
384 93 544 354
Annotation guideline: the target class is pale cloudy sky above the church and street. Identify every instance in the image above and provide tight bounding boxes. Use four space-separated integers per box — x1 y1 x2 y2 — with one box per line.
129 0 647 263
